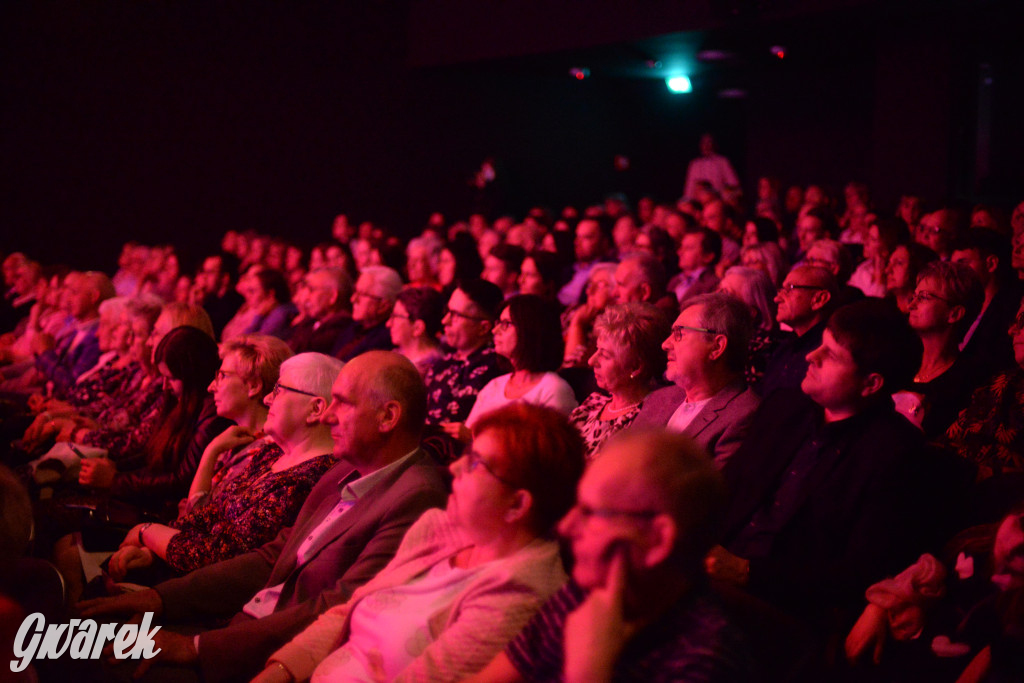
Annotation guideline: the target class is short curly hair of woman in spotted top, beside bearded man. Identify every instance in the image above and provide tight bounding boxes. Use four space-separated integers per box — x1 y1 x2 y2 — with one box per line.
594 302 672 381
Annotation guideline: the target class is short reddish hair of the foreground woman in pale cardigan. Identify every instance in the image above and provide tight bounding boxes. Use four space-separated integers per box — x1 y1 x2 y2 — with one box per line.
473 402 585 536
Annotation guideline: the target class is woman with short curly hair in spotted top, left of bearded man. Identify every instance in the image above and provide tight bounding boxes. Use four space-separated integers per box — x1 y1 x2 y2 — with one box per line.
569 303 671 460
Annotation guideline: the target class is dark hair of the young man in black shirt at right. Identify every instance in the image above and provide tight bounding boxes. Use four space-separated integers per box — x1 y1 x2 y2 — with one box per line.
826 299 924 395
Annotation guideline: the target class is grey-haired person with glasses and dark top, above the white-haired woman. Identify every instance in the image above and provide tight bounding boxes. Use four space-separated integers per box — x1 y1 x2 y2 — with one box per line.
331 265 401 360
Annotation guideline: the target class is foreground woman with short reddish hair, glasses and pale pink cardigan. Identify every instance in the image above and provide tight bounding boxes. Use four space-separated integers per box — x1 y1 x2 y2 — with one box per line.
248 403 584 683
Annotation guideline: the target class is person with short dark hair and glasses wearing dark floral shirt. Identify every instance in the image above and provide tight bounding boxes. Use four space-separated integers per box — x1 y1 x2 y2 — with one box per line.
424 280 509 428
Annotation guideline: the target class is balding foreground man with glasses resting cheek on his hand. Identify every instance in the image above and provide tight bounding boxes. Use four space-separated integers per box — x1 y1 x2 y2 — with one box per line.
470 427 752 683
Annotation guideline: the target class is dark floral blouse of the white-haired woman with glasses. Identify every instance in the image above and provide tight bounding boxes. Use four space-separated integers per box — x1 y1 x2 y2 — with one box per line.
161 442 335 573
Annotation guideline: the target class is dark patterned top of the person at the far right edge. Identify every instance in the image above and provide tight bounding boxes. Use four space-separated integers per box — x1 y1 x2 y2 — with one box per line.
940 370 1024 481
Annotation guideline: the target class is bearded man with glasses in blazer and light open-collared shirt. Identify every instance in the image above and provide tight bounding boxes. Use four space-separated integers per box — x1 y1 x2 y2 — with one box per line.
633 293 760 467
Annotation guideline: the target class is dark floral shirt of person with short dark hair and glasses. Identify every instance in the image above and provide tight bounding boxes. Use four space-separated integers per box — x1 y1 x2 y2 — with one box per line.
423 346 509 425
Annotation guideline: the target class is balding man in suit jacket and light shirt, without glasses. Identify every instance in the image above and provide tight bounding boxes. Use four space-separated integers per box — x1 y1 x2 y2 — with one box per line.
82 351 446 682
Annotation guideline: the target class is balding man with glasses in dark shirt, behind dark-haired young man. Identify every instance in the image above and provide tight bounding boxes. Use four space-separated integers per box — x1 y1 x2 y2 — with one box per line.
755 265 839 398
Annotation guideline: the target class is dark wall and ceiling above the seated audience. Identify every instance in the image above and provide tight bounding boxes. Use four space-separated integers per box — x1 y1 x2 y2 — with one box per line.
0 0 1024 267
